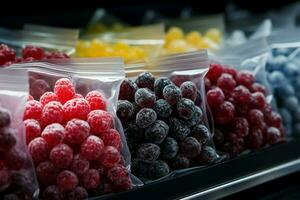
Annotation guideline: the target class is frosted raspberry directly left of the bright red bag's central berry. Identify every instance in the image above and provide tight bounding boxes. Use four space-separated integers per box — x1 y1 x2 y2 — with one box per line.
42 123 65 147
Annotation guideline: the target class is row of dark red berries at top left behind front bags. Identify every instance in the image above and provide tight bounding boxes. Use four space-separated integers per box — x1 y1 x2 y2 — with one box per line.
0 44 69 66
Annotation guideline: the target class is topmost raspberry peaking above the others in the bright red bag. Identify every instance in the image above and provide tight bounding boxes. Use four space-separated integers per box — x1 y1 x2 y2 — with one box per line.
54 78 75 104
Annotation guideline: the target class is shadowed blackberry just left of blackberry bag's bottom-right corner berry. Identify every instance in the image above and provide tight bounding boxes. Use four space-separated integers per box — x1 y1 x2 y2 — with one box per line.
180 137 201 158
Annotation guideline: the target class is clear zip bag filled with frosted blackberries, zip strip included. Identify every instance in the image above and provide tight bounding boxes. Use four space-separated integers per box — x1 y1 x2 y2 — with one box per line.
117 51 220 183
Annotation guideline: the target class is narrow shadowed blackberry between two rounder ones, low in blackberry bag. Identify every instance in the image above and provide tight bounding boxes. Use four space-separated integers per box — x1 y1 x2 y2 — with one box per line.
161 137 179 160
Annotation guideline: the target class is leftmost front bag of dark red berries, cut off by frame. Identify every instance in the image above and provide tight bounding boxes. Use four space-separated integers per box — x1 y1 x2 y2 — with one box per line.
0 69 39 200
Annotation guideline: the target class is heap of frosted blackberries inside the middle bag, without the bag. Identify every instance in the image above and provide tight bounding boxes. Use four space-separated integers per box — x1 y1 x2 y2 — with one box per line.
117 72 218 180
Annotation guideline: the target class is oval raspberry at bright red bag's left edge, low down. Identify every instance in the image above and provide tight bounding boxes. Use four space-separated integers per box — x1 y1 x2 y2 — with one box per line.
28 137 49 164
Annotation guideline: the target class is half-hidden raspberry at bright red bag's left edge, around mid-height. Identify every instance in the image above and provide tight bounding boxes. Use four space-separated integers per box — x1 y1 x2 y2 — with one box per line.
24 119 41 144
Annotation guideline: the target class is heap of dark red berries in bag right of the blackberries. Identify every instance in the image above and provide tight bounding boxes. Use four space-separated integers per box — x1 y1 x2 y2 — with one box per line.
205 64 284 156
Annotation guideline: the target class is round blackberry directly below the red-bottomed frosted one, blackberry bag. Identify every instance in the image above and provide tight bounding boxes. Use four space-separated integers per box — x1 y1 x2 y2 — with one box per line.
136 108 157 128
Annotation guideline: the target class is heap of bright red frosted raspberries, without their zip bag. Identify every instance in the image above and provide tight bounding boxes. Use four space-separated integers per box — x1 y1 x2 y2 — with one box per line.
24 78 132 199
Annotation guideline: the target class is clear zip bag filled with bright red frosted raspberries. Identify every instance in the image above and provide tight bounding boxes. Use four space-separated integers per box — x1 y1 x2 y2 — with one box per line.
13 58 133 199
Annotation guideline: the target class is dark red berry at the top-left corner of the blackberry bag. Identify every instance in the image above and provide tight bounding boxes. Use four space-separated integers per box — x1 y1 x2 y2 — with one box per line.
119 78 138 101
